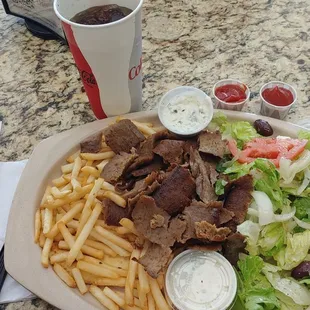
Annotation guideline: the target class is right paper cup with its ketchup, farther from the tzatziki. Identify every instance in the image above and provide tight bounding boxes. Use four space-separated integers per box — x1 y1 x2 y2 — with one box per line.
260 81 297 119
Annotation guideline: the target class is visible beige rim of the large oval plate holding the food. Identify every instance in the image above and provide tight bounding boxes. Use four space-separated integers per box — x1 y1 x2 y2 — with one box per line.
5 110 301 310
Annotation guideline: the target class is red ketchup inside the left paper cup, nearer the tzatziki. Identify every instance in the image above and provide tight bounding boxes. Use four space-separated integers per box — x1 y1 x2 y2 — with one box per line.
215 84 246 103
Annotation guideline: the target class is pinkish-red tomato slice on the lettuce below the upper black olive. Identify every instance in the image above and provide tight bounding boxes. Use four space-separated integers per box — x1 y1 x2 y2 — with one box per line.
228 138 308 167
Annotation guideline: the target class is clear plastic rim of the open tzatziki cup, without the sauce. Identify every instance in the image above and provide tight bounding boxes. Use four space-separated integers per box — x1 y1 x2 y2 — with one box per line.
157 86 213 136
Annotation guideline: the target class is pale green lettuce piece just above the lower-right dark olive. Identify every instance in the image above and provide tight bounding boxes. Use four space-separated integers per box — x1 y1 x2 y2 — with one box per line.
274 230 310 270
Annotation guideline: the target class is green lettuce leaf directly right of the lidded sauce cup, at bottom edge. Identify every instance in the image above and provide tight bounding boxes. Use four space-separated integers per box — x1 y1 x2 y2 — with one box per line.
238 256 280 310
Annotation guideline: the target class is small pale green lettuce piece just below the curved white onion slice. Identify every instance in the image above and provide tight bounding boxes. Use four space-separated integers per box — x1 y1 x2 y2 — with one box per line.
258 223 286 257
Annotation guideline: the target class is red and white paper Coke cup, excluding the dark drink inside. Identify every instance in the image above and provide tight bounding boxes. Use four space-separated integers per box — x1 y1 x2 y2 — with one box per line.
54 0 143 119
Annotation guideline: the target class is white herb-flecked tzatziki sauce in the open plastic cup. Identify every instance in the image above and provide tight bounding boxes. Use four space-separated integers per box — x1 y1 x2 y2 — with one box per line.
160 90 213 134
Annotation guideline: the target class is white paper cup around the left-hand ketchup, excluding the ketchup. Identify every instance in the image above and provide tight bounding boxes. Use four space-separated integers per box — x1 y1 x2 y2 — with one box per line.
212 79 251 111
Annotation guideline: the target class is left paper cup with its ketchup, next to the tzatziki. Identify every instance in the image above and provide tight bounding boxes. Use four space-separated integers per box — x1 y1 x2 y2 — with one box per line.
213 79 251 111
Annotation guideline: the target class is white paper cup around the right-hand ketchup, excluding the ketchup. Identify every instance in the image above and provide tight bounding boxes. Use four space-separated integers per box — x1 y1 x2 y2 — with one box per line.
259 81 297 119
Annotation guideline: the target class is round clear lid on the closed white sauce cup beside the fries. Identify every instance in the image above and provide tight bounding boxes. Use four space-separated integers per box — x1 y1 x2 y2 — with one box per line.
165 250 237 310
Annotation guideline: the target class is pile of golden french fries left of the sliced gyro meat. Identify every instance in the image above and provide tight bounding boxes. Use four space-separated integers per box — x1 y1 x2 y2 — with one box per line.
34 122 171 310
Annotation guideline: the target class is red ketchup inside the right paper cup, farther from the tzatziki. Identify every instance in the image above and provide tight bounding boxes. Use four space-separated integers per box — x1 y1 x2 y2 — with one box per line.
262 86 294 107
